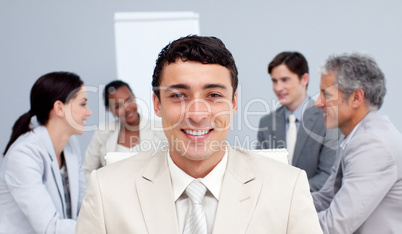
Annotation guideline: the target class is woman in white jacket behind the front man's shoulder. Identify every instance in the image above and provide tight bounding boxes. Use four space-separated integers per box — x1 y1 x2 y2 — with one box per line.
83 80 166 179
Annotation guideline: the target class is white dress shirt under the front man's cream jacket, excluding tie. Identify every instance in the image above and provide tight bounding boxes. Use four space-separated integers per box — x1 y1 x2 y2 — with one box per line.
166 151 228 234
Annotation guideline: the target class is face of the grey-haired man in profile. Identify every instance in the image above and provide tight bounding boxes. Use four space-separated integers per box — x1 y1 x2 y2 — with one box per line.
315 74 353 134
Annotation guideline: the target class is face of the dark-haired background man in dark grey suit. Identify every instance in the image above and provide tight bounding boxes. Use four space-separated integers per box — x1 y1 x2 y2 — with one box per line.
271 64 309 111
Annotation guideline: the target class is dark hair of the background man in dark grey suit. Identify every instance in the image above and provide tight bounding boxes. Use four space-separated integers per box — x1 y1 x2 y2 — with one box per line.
268 51 308 79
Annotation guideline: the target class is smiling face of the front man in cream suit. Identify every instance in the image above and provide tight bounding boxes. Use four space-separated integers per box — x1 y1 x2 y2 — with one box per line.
153 60 237 163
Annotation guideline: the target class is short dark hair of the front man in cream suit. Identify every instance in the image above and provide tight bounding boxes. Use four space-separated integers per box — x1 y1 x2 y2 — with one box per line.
152 35 238 98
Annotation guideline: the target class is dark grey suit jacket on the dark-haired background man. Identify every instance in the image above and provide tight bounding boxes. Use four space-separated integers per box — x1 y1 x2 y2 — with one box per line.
257 100 340 191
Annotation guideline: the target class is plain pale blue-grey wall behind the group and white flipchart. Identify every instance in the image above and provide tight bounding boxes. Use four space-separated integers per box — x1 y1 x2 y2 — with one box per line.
0 0 402 163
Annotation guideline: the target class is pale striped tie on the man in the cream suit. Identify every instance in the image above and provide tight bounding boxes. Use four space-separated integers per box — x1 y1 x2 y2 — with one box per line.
183 180 207 234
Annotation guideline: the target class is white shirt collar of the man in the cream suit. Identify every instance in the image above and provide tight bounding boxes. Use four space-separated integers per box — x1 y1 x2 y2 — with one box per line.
166 151 228 201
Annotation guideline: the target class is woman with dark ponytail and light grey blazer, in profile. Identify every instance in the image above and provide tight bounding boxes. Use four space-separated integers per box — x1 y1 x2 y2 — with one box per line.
0 72 92 233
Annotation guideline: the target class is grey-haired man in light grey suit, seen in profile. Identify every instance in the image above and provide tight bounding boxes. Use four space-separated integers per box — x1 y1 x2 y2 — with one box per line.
313 54 402 233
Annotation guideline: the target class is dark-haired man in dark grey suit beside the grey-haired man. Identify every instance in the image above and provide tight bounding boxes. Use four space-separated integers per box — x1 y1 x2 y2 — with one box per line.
258 52 338 191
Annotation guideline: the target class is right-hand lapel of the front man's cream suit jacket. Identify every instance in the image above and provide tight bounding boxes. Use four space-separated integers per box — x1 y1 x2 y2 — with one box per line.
213 149 262 233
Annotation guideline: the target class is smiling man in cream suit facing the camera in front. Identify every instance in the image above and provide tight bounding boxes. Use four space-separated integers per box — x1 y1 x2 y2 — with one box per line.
77 36 322 234
